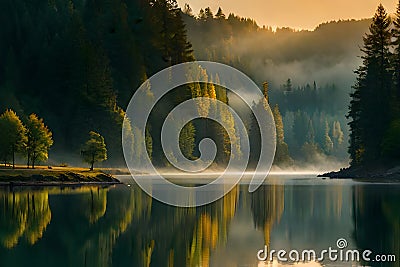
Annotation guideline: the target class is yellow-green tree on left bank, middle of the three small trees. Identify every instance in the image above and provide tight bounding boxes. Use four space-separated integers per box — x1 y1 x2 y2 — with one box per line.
26 114 53 168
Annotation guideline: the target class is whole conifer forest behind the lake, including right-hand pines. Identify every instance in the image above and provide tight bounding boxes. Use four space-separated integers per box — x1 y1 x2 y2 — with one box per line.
0 0 400 170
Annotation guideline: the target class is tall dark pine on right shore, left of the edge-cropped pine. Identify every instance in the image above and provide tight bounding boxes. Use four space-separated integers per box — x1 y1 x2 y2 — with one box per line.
348 5 392 165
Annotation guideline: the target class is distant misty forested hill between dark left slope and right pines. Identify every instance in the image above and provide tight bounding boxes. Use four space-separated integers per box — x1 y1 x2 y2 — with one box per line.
183 6 371 167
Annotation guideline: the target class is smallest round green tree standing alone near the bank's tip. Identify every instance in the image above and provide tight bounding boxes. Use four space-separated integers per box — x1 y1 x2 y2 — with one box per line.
82 131 107 170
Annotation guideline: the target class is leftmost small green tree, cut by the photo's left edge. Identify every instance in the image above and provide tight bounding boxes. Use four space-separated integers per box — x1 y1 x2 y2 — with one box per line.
0 109 27 168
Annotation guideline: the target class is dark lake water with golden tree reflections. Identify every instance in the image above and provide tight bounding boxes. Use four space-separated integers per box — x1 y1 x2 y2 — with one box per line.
0 176 400 267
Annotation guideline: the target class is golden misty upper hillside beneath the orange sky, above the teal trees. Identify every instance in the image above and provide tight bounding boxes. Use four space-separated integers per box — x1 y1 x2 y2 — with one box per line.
184 14 371 89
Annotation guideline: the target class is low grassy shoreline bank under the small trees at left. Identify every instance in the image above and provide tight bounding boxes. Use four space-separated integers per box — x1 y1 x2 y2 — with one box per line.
0 166 121 186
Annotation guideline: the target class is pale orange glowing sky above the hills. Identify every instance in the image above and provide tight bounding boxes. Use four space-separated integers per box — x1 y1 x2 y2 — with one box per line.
177 0 398 29
